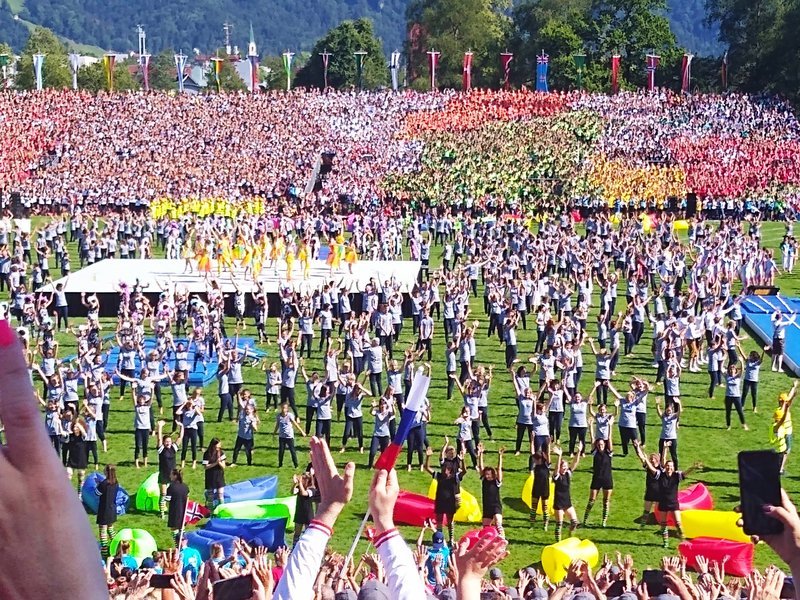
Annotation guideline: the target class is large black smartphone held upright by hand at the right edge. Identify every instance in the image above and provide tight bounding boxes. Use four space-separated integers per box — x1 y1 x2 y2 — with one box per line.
739 450 783 535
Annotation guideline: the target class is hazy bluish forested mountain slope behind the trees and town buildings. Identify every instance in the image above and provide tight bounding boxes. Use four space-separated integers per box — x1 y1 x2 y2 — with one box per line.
0 0 718 54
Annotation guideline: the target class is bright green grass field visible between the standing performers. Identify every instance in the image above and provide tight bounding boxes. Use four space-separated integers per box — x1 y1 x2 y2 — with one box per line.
23 220 800 575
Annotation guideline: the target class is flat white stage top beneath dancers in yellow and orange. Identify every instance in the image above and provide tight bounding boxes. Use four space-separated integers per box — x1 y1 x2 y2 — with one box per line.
41 259 422 294
